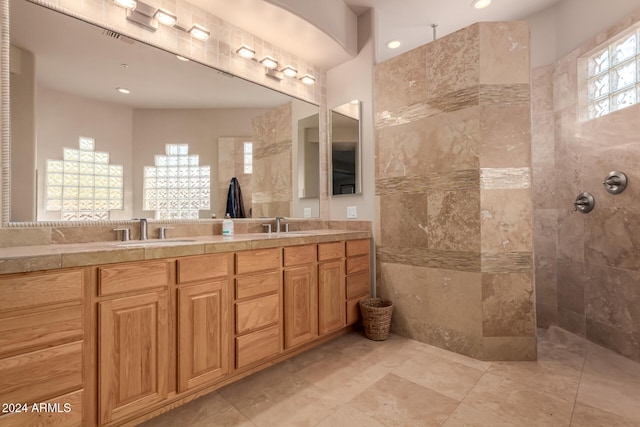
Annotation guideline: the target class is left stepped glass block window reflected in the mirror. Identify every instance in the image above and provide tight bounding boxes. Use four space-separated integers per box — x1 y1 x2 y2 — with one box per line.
45 137 124 221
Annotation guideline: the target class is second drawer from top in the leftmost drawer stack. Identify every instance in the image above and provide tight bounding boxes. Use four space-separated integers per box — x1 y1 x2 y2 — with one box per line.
0 306 82 356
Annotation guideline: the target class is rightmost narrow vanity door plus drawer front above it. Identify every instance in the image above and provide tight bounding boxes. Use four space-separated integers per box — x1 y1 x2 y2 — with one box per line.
318 242 346 335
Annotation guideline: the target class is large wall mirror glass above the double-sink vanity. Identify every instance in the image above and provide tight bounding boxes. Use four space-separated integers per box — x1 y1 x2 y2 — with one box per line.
10 0 320 222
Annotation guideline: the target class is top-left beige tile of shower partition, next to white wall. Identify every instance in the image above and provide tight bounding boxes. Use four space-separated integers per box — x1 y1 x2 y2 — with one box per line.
373 46 427 111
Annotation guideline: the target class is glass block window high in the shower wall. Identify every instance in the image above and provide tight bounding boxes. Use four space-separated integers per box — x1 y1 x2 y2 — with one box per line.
587 29 640 119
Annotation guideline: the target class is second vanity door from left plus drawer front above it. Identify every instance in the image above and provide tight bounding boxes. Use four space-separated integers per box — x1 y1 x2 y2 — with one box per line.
177 254 233 393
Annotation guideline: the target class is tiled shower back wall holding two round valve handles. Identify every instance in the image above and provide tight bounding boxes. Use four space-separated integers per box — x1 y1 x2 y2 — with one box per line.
533 9 640 361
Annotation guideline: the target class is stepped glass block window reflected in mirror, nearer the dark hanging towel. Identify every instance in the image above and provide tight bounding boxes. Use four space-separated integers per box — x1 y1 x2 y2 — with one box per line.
142 144 211 219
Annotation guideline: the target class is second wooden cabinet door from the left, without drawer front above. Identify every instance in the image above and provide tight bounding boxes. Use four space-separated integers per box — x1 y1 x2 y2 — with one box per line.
178 279 230 392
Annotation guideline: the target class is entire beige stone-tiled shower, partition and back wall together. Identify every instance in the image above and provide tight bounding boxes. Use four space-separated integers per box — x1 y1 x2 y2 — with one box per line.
374 9 640 361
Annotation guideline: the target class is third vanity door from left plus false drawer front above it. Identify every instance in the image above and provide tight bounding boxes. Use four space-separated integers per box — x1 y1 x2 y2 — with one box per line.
284 245 318 349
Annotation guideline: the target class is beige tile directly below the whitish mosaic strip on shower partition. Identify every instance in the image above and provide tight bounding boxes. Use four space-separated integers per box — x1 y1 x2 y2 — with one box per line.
480 189 533 252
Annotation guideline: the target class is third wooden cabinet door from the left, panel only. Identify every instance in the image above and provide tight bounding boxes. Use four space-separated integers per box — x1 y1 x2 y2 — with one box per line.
284 264 318 348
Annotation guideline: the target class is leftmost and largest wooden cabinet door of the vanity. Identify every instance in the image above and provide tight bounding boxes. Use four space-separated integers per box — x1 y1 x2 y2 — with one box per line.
98 291 169 424
